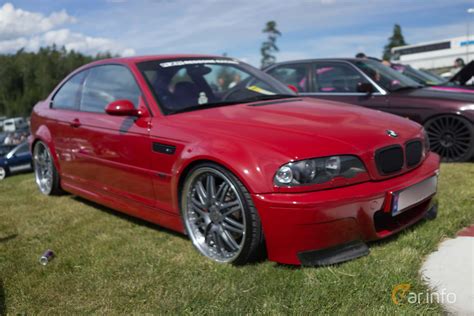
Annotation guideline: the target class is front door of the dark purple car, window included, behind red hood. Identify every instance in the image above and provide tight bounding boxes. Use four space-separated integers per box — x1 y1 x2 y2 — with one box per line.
306 61 388 110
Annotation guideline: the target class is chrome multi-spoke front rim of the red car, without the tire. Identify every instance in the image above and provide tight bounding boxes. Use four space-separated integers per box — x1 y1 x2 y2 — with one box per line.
183 167 246 262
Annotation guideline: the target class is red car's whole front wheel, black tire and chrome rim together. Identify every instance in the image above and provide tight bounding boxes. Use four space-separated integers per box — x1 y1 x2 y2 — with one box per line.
181 163 265 265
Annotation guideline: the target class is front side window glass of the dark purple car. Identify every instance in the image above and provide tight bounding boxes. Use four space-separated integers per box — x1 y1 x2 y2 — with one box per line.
314 63 368 93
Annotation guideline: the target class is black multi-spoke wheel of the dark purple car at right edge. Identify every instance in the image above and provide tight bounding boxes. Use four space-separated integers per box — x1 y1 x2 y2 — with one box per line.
424 115 474 162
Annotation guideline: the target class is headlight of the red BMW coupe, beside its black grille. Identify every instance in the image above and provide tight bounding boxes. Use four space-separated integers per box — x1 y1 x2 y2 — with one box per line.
274 156 367 186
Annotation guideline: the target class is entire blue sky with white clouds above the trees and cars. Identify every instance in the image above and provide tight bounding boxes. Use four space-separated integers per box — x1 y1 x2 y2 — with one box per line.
0 0 474 66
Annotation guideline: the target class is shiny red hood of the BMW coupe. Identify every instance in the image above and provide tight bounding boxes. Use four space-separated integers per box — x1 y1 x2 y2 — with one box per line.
168 98 421 159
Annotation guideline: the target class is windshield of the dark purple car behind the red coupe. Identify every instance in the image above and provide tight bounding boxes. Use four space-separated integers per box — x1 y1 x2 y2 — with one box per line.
354 60 421 91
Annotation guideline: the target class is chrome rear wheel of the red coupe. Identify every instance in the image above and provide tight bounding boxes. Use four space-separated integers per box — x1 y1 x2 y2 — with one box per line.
33 142 53 195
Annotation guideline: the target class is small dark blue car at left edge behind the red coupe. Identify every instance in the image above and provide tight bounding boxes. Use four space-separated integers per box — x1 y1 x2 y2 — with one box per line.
0 142 32 180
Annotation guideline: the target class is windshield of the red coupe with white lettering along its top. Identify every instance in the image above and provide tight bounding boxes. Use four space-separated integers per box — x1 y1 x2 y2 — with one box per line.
138 58 296 114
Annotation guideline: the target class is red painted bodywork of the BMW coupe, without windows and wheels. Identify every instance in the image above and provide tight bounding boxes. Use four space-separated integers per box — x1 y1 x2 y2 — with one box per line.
30 55 439 264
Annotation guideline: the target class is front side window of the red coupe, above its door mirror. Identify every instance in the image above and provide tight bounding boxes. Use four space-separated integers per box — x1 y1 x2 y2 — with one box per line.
80 65 140 113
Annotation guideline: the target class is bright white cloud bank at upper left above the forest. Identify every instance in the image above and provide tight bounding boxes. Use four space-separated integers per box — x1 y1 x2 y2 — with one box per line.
0 3 135 56
